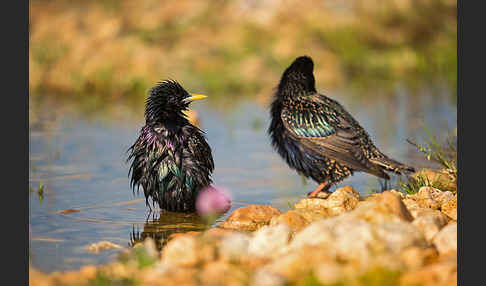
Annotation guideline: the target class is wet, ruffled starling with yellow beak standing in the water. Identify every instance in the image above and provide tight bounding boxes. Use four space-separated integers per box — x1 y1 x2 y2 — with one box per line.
127 80 214 212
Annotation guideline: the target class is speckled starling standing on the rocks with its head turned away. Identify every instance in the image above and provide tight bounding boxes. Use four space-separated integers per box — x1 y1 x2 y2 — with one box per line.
268 56 414 197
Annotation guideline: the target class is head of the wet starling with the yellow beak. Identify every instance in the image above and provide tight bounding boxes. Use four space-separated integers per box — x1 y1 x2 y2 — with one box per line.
145 80 207 121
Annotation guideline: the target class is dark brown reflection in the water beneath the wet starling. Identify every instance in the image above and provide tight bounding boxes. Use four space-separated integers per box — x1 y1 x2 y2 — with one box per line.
128 211 228 250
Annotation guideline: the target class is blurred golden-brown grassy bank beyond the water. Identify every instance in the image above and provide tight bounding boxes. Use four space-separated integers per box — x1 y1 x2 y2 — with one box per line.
29 0 457 105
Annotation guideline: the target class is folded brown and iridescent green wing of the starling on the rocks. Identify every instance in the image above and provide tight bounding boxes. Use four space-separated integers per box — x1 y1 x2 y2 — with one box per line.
281 100 388 178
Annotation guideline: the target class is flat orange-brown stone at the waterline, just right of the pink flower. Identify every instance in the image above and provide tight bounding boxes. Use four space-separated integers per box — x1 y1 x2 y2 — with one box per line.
220 205 280 231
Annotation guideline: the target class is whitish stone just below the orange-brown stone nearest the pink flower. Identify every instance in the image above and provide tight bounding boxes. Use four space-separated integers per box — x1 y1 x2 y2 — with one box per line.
248 224 290 258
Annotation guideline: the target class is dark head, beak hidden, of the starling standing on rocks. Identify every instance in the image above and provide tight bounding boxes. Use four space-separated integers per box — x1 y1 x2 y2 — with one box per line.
277 56 316 96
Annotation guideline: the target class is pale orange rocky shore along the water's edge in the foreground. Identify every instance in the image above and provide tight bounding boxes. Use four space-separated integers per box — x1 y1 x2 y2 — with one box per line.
30 182 457 286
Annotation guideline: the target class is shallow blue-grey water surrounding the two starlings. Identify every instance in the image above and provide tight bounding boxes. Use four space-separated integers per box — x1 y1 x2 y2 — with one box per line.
29 88 457 272
